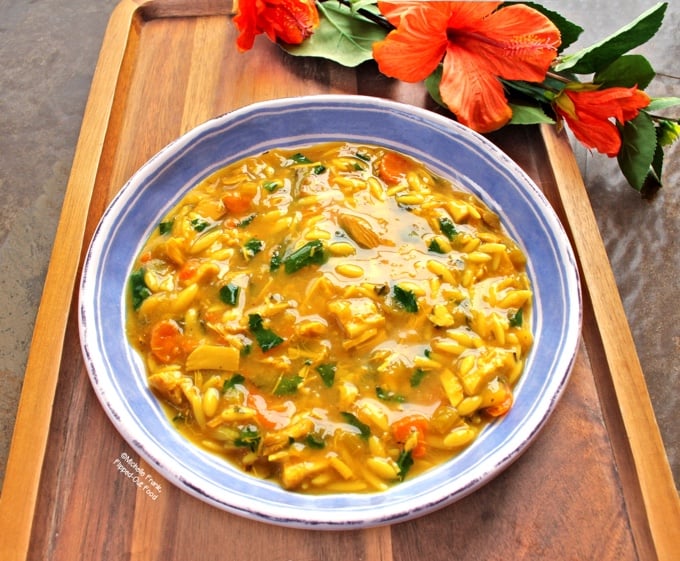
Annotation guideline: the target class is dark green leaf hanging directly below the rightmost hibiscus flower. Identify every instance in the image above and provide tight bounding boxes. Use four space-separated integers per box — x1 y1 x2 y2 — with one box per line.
617 113 657 191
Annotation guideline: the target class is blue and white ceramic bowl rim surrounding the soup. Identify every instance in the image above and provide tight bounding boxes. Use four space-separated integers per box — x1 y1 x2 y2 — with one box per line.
79 95 581 529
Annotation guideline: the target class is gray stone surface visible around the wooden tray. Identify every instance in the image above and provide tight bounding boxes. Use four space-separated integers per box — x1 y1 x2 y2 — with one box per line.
0 0 680 490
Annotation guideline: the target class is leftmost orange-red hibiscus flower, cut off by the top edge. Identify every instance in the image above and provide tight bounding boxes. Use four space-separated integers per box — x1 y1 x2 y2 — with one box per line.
234 0 319 51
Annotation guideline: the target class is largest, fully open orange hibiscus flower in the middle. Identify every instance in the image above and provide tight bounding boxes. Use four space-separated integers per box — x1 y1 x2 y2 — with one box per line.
373 1 560 132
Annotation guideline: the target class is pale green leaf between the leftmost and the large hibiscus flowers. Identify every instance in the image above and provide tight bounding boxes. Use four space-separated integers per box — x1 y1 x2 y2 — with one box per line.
281 2 387 67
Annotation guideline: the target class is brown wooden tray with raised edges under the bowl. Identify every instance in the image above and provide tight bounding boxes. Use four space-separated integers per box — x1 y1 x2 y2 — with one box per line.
0 0 680 561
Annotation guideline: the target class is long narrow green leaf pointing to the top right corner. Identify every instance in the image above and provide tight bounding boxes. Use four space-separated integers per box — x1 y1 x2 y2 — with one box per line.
554 2 668 74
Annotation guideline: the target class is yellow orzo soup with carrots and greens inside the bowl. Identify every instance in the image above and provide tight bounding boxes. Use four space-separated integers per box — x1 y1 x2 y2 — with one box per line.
128 143 532 493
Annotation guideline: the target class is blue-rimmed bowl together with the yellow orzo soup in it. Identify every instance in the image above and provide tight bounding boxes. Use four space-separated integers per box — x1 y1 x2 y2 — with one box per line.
79 95 581 529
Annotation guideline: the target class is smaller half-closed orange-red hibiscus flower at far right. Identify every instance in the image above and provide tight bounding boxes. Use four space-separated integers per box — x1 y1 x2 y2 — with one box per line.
554 85 650 157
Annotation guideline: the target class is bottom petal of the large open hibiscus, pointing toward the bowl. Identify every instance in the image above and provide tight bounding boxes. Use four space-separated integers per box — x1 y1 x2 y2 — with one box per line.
439 45 512 132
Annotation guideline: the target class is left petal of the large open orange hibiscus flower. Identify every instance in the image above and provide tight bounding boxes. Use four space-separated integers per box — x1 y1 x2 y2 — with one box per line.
373 3 448 82
